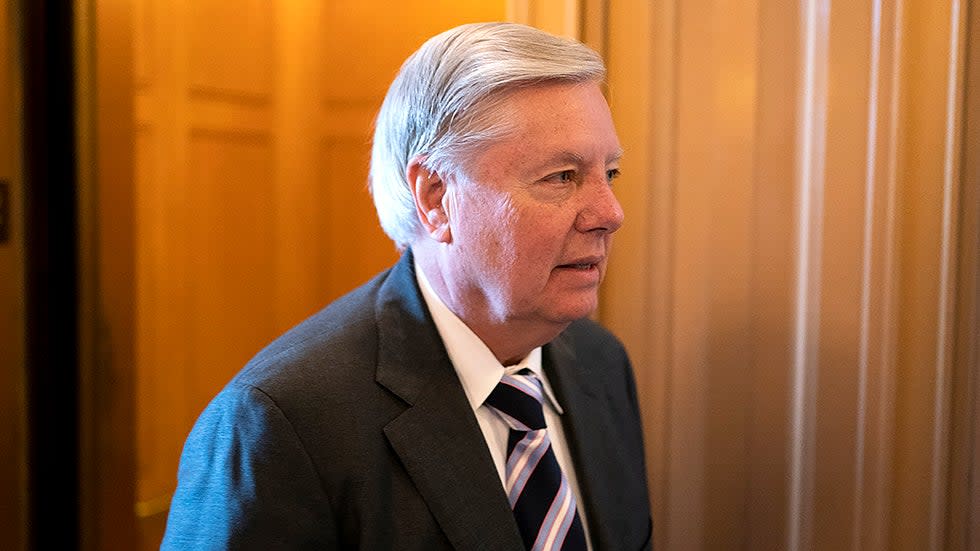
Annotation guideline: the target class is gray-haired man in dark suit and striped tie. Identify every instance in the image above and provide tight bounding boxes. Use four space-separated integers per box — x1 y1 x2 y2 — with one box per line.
163 19 652 550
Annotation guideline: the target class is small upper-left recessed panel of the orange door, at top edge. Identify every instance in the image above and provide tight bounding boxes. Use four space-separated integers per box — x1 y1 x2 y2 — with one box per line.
185 0 274 98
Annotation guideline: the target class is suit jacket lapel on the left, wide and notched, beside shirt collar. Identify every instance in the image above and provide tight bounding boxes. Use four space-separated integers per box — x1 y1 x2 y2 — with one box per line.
376 253 522 550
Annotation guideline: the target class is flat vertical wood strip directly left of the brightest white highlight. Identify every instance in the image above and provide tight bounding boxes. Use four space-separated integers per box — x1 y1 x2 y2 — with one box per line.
745 0 803 550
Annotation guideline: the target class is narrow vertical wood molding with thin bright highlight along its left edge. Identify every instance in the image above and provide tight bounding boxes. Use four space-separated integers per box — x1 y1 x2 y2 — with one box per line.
851 2 903 550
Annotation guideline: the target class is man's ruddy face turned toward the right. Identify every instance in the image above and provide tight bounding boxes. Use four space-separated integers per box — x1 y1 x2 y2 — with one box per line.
446 83 623 325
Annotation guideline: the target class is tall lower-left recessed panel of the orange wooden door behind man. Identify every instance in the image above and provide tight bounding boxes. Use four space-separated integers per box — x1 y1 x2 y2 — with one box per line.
186 132 276 411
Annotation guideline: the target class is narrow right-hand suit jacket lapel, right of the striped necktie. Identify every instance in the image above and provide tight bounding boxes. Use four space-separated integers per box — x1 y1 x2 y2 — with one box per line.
543 334 618 550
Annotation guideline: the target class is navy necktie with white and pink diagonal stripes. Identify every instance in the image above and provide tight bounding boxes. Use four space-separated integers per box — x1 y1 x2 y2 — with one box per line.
485 369 587 551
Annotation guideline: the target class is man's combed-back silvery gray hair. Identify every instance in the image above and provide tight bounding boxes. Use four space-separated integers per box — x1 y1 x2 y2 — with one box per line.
370 23 606 250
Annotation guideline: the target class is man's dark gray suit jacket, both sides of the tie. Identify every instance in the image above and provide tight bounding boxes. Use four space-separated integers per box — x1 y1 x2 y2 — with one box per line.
162 253 652 551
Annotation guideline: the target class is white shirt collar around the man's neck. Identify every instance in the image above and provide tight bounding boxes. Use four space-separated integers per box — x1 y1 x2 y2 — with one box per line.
415 260 563 414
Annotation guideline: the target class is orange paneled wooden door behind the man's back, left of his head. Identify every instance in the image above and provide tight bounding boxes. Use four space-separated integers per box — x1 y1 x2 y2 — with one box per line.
133 0 505 549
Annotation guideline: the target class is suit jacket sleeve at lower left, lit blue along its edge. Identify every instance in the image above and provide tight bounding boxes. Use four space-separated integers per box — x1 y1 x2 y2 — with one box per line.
161 383 337 550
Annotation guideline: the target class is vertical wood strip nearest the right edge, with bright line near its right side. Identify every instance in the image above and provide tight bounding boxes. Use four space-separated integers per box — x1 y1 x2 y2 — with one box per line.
892 0 963 551
